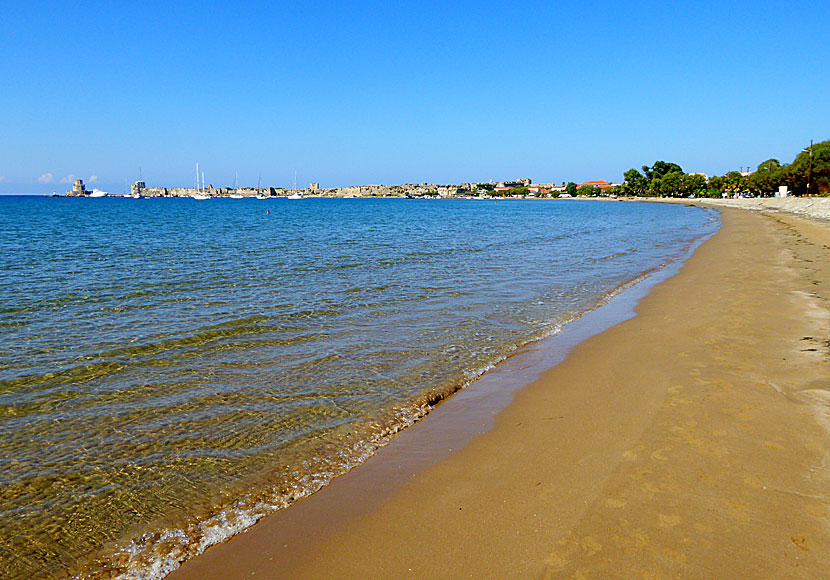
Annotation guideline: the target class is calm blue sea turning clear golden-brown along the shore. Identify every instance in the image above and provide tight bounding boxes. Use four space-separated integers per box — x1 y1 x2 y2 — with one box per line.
0 196 720 579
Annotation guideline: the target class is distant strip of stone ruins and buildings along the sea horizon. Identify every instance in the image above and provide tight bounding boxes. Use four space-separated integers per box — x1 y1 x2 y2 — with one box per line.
66 179 621 199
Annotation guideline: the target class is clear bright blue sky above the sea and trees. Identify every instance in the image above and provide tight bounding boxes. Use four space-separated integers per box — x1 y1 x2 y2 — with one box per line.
0 0 830 193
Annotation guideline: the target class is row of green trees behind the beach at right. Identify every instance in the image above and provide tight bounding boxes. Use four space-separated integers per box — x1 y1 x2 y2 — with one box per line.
609 141 830 197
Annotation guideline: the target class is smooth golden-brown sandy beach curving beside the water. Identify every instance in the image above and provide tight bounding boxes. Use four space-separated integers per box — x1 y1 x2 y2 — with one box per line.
168 207 830 580
